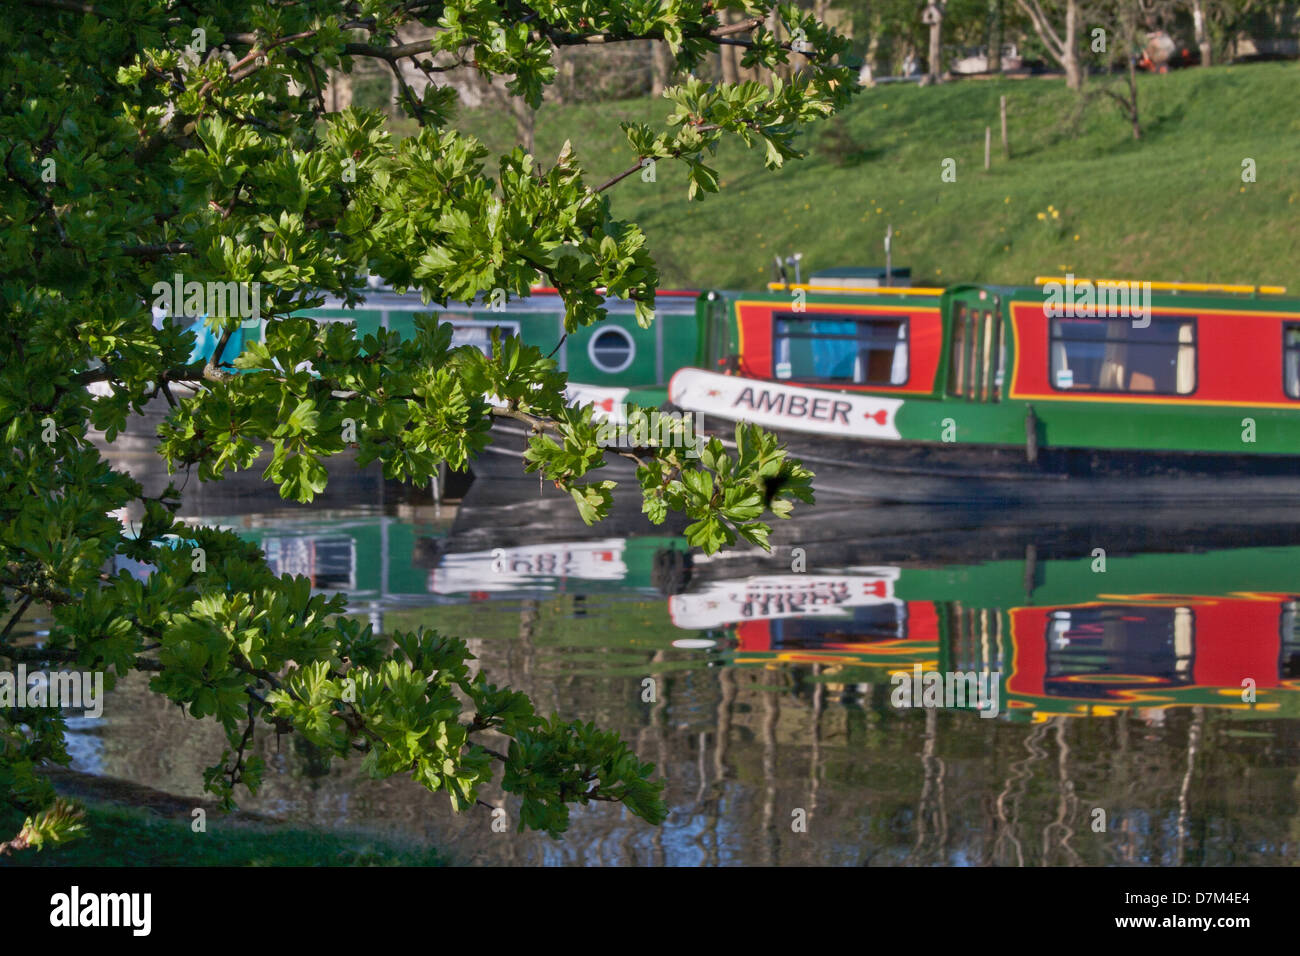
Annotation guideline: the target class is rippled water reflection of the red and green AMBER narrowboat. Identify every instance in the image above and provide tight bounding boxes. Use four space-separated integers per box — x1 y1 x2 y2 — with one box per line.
670 548 1300 721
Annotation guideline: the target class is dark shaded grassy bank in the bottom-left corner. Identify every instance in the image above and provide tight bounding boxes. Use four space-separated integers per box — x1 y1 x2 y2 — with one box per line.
0 803 450 868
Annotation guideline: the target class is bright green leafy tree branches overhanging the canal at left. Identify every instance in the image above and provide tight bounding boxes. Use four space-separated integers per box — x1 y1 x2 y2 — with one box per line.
0 0 853 845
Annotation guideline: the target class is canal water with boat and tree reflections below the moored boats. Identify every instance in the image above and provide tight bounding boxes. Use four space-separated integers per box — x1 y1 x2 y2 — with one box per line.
43 455 1300 866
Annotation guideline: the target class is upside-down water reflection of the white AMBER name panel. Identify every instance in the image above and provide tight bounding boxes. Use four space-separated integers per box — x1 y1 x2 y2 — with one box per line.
668 567 898 630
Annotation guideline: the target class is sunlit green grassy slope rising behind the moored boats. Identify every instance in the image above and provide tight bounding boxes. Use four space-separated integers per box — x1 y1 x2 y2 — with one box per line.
462 64 1300 289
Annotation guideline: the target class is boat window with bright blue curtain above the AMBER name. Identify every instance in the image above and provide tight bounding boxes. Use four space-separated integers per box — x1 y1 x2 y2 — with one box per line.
772 312 909 385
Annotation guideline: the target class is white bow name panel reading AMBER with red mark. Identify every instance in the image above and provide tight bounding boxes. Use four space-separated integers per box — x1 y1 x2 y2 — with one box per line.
668 368 902 438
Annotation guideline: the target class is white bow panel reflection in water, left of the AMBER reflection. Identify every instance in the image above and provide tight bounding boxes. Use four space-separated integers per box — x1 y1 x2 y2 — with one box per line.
429 537 628 594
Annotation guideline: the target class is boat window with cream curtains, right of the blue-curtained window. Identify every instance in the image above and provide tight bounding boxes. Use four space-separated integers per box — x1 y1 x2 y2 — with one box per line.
1050 317 1196 395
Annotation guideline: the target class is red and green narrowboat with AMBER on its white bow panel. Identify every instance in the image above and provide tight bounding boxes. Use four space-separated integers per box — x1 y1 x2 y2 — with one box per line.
670 276 1300 503
